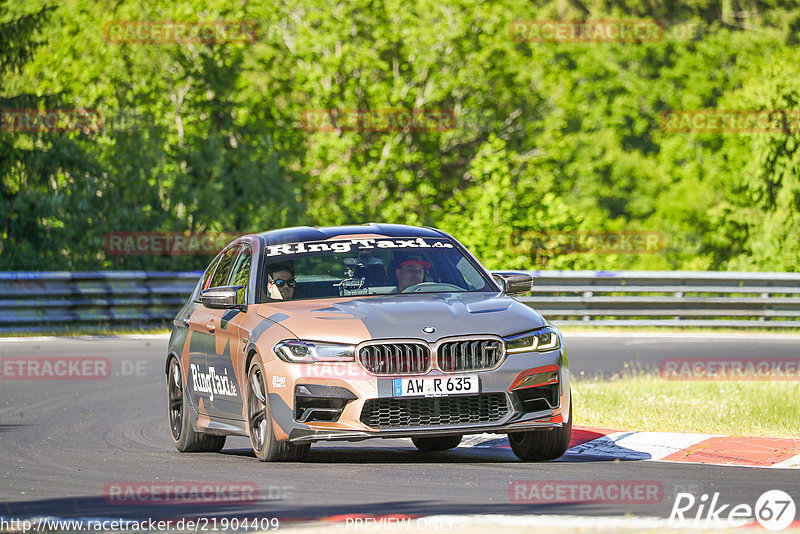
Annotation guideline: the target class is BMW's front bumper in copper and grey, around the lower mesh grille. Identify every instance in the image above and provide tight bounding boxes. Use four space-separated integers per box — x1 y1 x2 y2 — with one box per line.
268 343 571 443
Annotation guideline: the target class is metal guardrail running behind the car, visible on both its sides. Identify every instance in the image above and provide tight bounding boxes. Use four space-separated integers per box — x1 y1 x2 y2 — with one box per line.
0 271 800 332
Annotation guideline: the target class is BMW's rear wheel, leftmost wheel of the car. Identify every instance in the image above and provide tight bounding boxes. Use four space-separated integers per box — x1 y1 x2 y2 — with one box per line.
167 357 225 452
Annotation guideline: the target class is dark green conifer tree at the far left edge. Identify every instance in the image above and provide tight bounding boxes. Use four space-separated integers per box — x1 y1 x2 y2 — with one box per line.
0 4 101 269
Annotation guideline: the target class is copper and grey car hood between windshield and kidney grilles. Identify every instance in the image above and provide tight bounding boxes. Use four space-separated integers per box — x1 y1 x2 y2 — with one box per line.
259 293 545 343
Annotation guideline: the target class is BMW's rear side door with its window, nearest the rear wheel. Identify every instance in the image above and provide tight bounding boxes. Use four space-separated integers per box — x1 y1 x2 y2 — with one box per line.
188 245 241 415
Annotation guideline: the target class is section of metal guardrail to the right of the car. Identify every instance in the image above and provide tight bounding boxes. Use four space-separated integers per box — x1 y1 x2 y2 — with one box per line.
519 271 800 328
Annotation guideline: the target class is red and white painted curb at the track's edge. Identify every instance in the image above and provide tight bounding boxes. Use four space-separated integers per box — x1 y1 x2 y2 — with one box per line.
459 427 800 468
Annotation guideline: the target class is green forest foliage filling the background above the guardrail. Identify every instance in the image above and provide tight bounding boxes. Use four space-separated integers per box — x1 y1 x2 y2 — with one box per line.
0 0 800 271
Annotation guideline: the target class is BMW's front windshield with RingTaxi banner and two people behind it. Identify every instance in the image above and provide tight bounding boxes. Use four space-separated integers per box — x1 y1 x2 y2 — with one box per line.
261 237 496 301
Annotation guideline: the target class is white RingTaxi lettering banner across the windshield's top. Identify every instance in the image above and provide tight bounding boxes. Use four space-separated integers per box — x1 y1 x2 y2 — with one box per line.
266 237 453 258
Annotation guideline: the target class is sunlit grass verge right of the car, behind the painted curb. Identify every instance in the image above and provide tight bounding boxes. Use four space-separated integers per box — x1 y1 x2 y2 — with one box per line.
572 374 800 438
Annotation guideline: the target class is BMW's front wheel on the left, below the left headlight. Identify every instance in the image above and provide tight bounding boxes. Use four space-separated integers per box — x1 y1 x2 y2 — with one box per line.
247 357 311 462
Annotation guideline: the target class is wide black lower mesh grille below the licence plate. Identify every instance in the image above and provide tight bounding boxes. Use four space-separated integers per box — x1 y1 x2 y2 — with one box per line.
361 393 508 428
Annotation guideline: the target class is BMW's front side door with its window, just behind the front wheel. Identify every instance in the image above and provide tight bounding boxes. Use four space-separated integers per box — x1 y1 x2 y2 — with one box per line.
206 244 252 420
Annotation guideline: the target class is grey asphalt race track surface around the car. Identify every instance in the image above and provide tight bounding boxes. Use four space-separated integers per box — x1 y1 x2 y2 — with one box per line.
0 333 800 521
